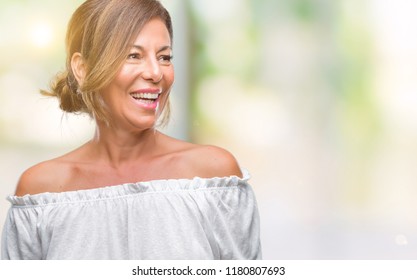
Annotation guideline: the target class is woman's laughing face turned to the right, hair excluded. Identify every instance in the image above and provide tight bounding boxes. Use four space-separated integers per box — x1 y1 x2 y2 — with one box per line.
101 19 174 130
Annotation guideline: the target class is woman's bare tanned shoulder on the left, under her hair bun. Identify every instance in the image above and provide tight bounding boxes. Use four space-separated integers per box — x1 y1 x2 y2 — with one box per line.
15 159 68 196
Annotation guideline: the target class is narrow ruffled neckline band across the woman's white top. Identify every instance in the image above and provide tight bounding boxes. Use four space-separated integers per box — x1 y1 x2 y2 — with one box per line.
7 169 250 207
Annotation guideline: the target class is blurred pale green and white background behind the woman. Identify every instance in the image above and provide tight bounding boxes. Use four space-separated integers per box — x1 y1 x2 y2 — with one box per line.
0 0 417 259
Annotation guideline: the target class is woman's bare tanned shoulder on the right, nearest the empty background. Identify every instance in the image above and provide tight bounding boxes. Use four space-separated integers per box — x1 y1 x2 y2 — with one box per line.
178 144 242 178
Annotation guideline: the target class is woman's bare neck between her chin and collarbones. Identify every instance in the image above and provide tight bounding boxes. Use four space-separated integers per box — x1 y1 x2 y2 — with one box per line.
90 124 159 168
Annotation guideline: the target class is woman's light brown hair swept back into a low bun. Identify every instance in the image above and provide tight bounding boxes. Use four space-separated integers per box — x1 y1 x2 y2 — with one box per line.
41 0 173 124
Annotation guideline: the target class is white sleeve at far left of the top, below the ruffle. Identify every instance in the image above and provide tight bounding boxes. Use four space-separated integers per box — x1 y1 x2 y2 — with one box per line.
1 207 42 260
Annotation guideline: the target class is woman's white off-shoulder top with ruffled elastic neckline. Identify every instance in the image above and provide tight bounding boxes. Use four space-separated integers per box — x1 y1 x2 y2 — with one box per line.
1 171 261 260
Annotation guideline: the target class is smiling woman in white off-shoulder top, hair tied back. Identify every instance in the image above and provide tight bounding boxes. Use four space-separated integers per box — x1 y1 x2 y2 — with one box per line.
2 0 261 259
